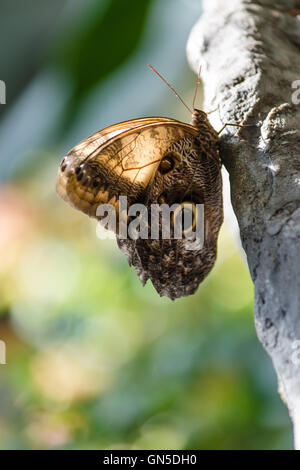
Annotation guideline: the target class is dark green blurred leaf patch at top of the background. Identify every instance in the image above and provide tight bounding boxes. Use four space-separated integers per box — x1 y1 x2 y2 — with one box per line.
54 0 151 99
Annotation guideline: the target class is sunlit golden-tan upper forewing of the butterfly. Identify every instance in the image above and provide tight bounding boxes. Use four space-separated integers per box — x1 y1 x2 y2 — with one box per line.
56 117 197 217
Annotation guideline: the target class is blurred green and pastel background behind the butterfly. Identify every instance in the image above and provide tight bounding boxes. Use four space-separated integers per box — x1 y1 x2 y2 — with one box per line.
0 0 292 449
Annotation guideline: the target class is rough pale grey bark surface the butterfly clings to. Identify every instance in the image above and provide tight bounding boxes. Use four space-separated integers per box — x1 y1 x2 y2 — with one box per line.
187 0 300 449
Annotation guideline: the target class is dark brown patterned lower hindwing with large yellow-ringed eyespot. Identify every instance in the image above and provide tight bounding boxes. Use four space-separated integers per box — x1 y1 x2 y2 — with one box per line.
118 126 223 299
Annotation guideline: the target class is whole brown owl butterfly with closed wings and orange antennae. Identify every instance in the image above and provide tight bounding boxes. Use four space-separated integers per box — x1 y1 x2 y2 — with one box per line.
57 66 223 299
